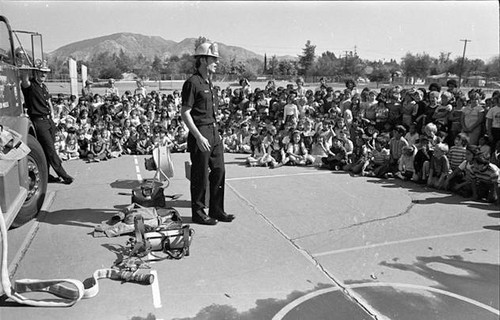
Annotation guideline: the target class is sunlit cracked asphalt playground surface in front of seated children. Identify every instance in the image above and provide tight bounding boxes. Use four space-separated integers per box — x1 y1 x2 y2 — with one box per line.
0 154 500 320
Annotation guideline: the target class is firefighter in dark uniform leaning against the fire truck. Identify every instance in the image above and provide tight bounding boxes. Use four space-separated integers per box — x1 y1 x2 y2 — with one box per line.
21 64 74 184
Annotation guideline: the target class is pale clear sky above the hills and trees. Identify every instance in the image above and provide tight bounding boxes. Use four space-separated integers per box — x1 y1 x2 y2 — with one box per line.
0 0 500 61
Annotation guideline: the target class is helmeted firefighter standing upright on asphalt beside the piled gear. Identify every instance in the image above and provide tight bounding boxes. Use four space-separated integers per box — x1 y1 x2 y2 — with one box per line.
181 42 234 225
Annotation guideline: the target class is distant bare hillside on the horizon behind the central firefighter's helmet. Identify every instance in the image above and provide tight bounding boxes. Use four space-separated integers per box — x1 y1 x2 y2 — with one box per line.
49 33 264 61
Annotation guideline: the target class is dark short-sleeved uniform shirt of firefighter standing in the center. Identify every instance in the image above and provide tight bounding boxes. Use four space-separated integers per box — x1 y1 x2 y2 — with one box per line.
182 73 219 127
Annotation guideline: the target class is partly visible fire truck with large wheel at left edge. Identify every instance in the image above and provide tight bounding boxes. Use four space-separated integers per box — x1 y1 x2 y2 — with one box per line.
0 15 48 227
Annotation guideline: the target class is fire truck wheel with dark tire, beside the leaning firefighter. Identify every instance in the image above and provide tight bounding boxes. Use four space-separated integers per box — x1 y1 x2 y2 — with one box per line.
11 135 49 228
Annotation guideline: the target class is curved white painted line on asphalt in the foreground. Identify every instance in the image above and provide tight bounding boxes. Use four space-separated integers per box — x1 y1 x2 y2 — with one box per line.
272 282 500 320
